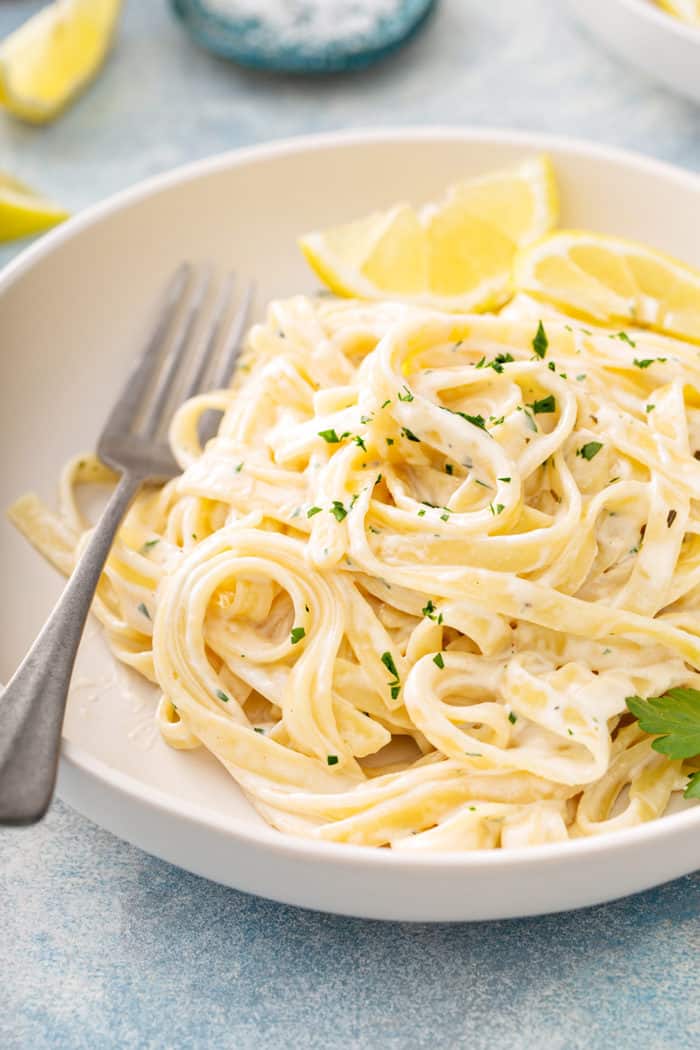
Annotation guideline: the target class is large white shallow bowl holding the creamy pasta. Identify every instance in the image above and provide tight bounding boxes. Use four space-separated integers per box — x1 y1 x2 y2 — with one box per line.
0 129 700 921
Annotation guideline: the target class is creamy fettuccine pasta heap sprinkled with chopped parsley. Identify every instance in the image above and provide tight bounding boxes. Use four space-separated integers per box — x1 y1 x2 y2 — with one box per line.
12 297 700 851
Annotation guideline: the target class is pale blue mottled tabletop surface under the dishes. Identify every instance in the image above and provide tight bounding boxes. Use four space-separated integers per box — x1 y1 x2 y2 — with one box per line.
0 0 700 1050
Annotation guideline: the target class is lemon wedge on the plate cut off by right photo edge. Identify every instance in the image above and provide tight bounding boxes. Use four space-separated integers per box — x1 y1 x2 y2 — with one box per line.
515 230 700 342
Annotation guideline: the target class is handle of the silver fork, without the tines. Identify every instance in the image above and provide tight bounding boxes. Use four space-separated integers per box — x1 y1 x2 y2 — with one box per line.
0 474 143 825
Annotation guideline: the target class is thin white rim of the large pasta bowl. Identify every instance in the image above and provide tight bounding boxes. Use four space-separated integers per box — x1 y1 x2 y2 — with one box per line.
5 127 700 873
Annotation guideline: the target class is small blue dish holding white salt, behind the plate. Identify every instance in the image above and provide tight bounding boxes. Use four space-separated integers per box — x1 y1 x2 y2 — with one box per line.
171 0 437 74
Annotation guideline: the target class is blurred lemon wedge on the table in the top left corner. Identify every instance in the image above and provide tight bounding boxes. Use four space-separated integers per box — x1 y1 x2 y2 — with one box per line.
0 0 122 124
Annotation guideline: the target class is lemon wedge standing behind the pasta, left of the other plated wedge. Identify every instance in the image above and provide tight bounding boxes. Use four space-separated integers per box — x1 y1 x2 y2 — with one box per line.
299 156 557 310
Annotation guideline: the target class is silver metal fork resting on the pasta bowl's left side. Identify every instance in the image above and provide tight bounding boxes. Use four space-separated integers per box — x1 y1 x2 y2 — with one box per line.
0 264 253 824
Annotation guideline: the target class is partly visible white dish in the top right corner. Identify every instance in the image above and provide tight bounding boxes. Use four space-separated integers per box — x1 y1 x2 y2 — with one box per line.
569 0 700 102
